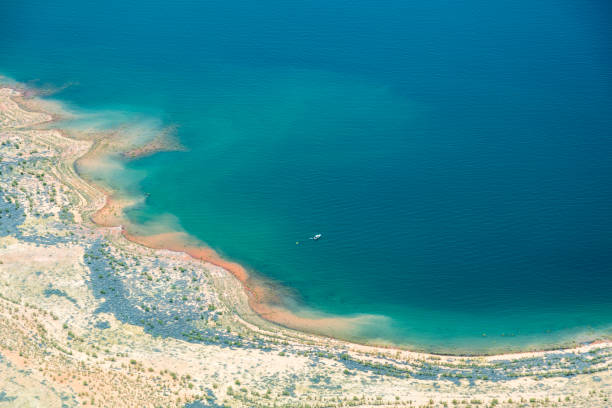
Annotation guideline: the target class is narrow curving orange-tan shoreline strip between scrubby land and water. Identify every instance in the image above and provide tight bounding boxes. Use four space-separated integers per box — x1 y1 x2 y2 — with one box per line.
5 77 609 356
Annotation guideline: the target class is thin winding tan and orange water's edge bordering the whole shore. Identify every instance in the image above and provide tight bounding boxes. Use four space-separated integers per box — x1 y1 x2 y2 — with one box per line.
5 79 612 357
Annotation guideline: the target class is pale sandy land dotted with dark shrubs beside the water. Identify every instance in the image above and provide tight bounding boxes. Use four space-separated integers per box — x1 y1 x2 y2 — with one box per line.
0 81 612 407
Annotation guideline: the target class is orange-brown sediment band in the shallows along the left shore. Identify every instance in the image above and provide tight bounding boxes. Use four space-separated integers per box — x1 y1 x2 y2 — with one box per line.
70 111 370 336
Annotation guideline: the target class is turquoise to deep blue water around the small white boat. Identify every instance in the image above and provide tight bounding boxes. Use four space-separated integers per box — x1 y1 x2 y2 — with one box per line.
0 0 612 352
